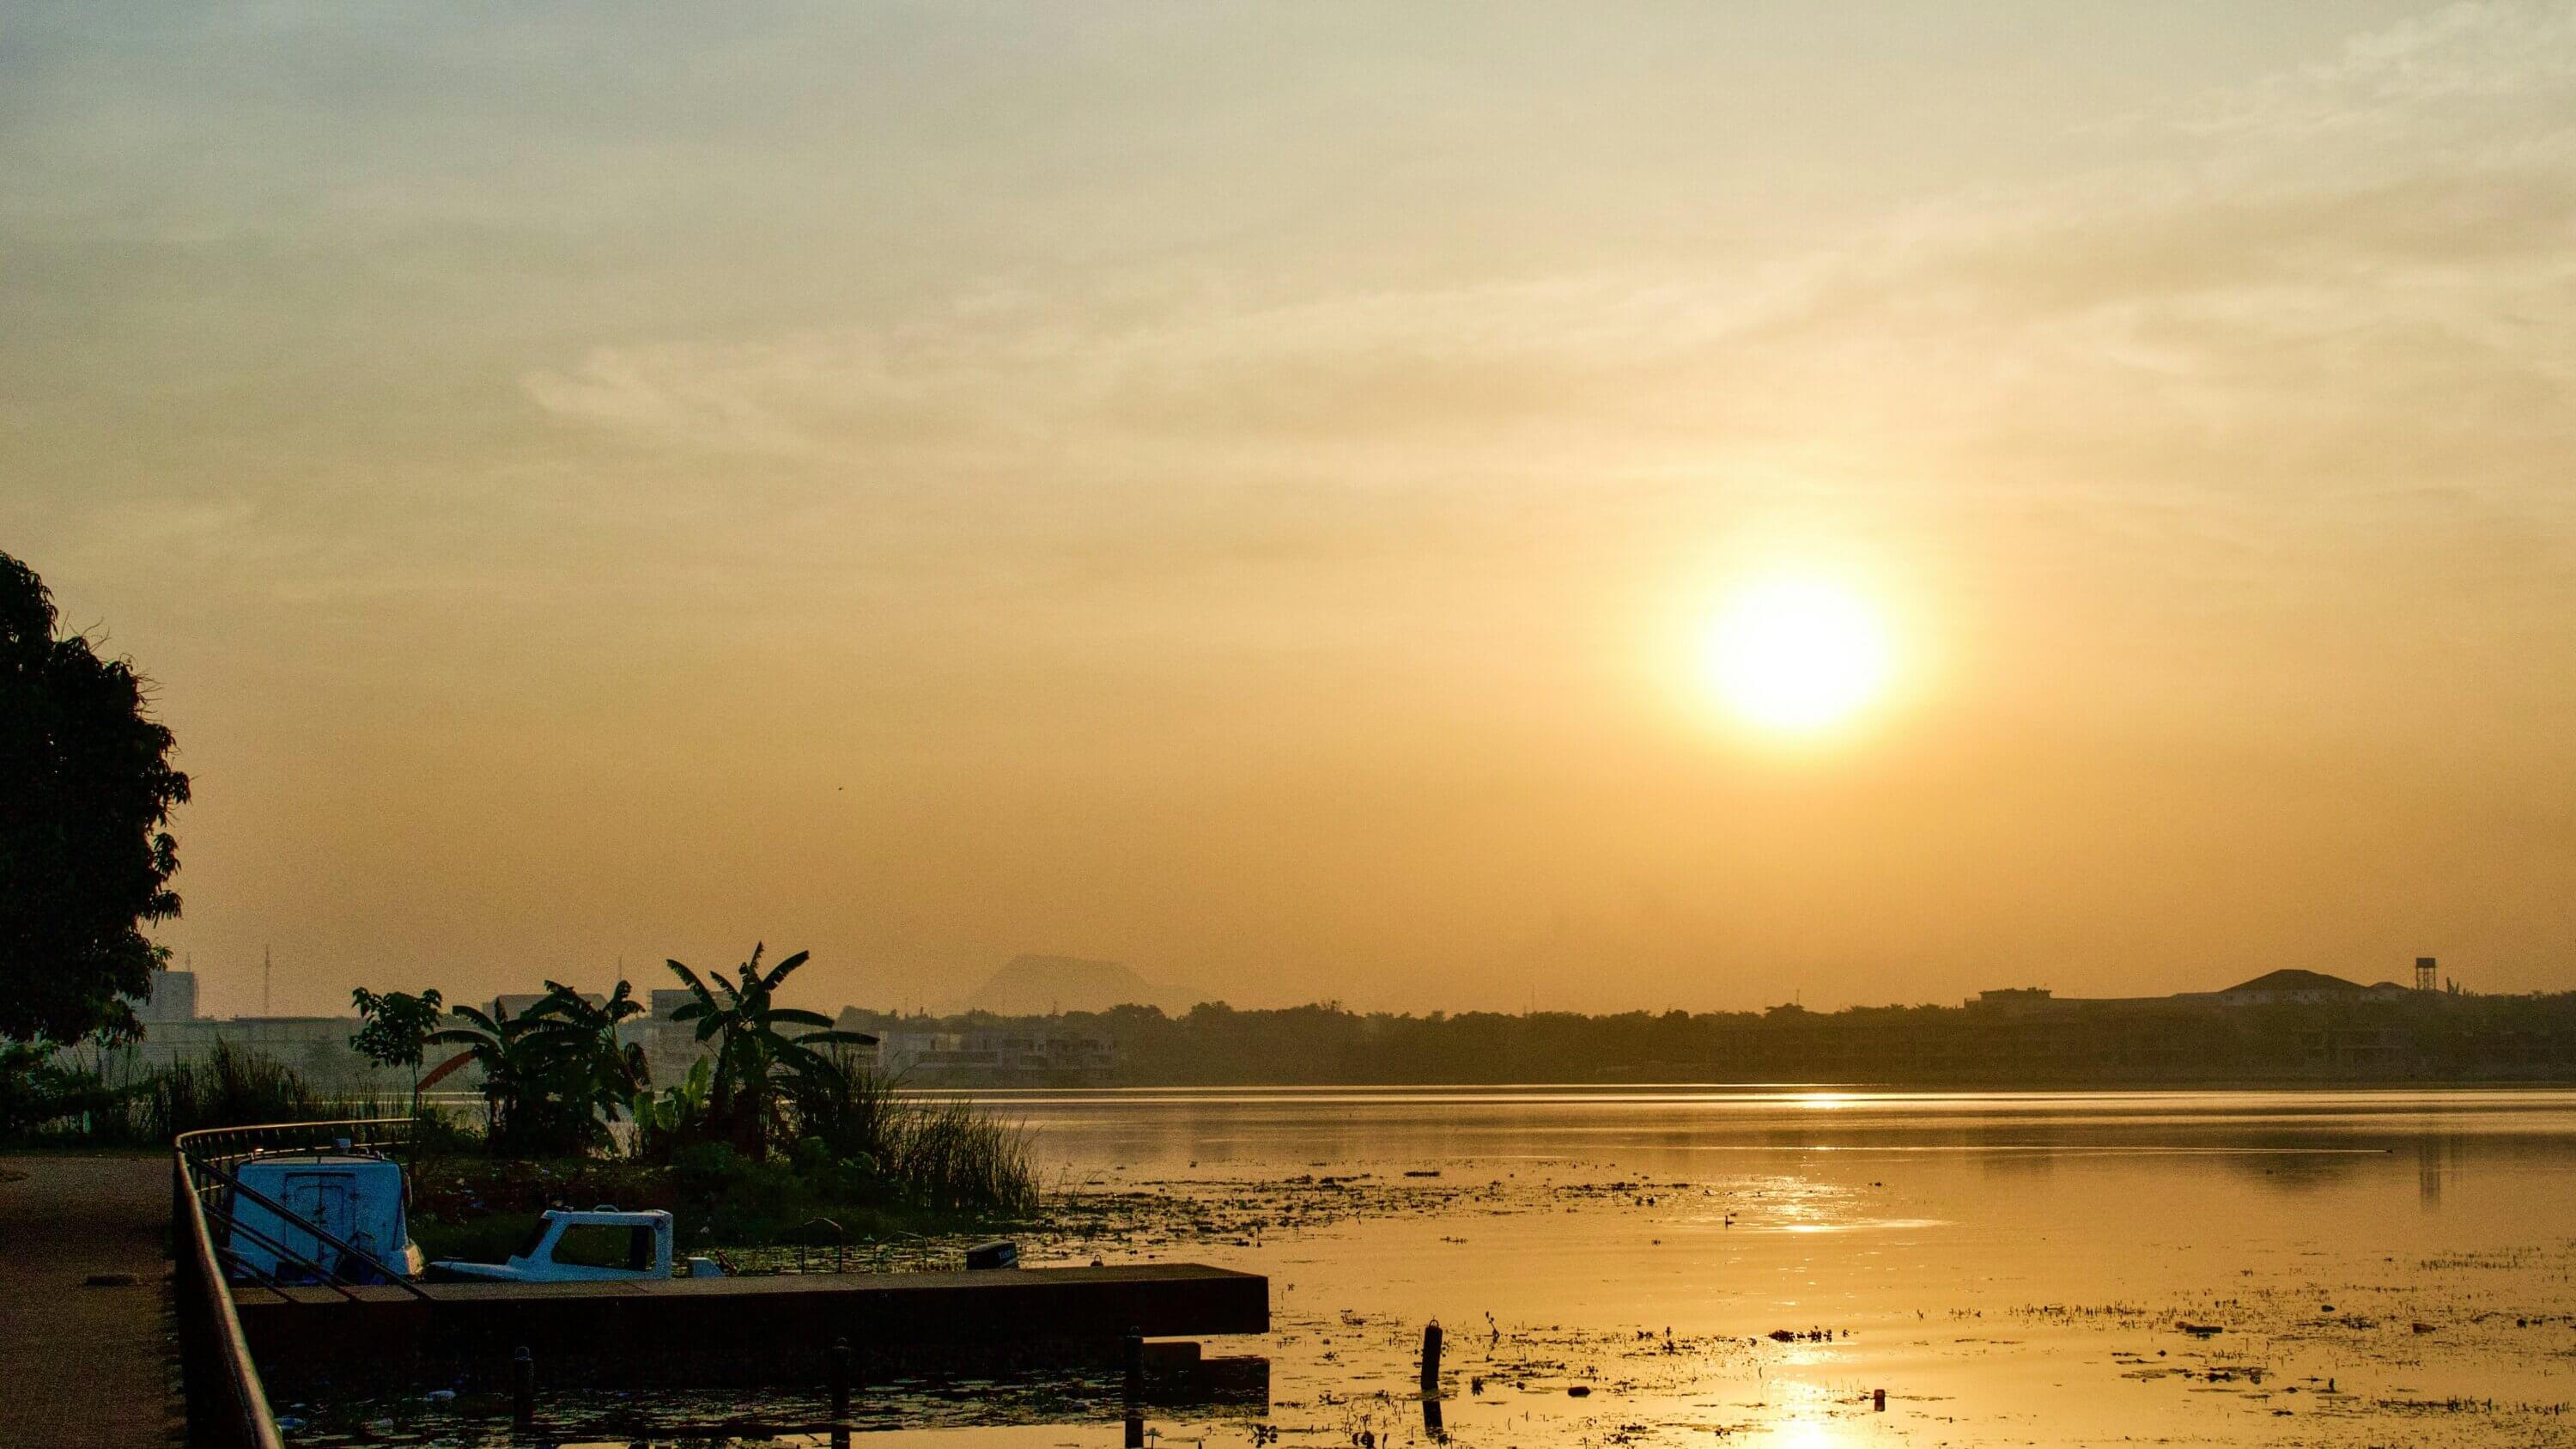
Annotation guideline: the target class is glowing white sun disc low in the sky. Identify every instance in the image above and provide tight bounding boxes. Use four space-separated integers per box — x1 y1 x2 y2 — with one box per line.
1705 575 1891 735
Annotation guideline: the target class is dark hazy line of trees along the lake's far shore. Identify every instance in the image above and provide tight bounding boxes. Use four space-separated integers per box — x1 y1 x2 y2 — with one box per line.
881 993 2576 1086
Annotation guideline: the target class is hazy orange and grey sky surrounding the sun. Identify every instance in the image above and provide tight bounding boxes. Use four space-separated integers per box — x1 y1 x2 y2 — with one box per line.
0 0 2576 1014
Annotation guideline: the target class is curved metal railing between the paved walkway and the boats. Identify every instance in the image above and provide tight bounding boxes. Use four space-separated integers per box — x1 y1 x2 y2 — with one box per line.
170 1117 420 1449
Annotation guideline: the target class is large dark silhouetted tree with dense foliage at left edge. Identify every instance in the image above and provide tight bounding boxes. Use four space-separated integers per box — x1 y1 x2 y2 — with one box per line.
0 554 188 1042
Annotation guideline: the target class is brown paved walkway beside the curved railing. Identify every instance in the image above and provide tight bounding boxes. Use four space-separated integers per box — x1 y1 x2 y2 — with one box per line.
0 1153 185 1449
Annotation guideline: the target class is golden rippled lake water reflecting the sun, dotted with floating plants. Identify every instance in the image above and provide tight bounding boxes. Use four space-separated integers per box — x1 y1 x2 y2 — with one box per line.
312 1088 2576 1449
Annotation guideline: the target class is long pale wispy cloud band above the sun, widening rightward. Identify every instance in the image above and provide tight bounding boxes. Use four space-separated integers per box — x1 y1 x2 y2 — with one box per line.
523 5 2576 510
